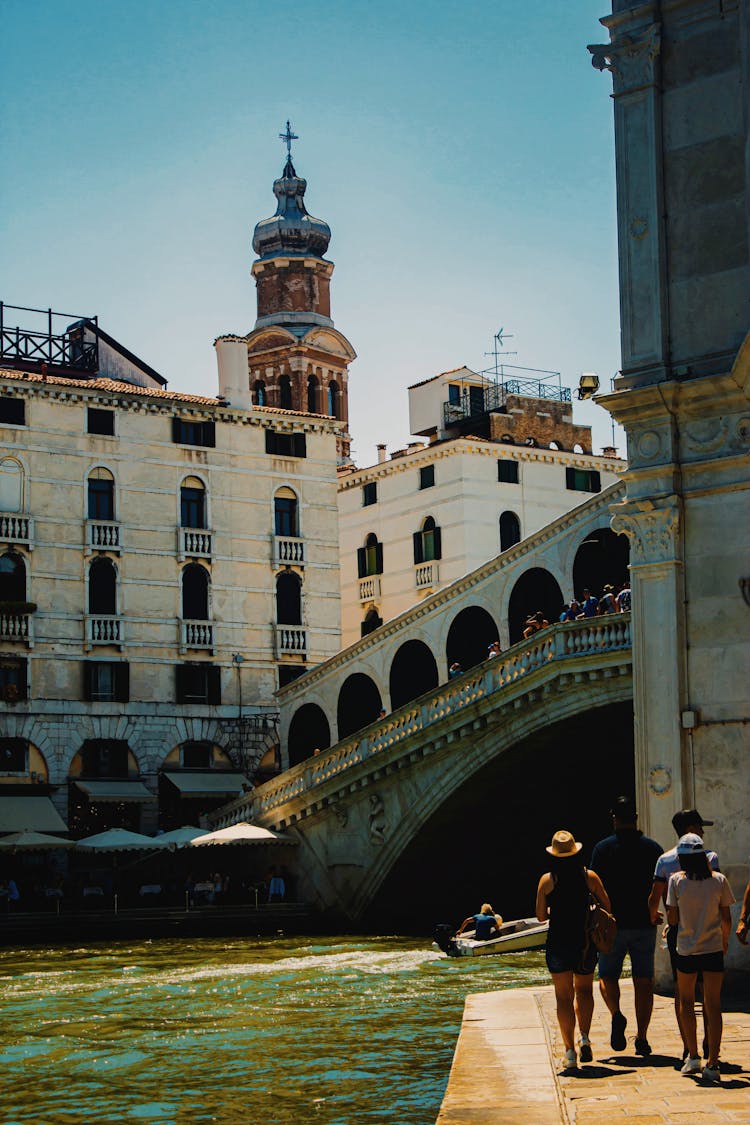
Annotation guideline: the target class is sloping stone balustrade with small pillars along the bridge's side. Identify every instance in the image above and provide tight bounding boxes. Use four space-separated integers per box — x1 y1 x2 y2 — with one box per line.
231 613 631 824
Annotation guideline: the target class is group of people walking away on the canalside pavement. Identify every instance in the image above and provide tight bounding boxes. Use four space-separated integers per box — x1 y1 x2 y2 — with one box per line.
536 797 750 1082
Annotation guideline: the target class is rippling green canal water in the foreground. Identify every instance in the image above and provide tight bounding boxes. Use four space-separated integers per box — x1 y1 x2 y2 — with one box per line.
0 937 548 1125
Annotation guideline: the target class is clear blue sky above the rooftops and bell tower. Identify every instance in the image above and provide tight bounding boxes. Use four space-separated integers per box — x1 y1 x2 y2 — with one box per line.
0 0 624 465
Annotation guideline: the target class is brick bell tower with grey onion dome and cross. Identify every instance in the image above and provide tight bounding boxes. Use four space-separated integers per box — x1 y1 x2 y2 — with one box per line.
247 122 356 464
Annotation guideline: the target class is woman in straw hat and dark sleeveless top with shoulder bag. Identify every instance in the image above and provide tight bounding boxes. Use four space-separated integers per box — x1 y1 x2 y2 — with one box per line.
536 829 609 1068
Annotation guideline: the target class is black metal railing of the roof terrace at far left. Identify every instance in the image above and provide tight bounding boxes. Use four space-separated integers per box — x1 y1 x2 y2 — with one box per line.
0 300 99 371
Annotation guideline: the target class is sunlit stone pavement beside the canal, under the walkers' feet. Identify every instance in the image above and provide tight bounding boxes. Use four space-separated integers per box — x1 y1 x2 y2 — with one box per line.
437 981 750 1125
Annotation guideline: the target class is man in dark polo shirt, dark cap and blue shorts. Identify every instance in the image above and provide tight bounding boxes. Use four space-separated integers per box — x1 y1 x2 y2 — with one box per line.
589 797 661 1055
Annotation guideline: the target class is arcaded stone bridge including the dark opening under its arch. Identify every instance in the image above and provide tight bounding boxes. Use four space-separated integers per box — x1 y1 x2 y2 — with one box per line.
211 485 633 928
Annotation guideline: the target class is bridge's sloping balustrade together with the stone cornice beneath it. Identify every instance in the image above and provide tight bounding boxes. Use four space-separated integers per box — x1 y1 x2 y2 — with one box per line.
211 613 631 827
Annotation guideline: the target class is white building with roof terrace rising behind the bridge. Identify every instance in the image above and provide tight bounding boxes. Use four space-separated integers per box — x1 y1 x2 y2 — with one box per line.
338 368 625 645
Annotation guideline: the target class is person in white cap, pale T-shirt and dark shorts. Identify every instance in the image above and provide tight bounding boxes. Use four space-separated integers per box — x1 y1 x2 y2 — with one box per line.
667 833 734 1082
